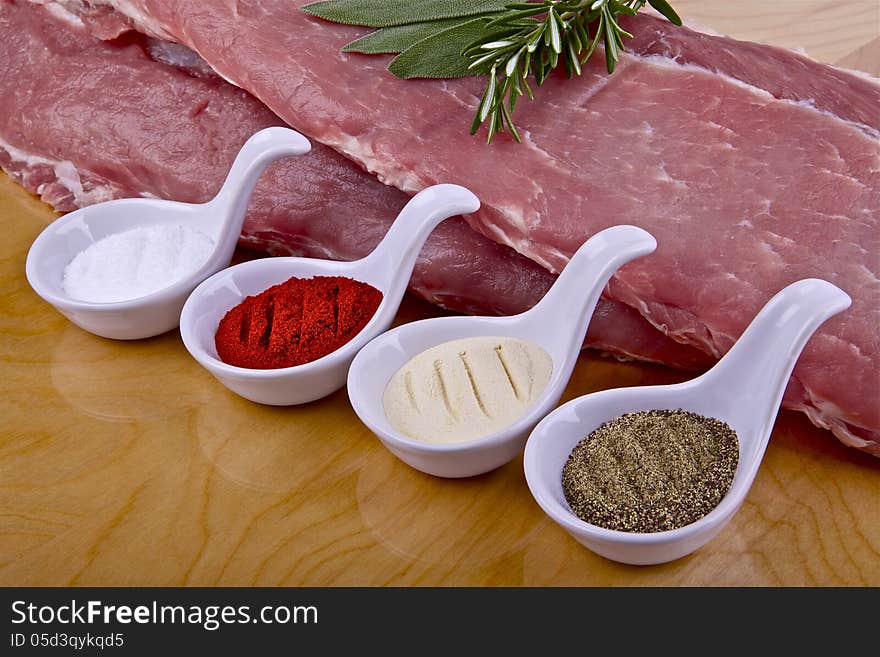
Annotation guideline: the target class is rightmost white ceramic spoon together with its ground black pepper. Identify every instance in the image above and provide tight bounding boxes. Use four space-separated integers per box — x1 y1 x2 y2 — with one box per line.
524 279 851 565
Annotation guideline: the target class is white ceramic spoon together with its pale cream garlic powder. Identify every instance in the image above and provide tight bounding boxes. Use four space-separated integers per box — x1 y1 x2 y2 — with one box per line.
348 226 657 477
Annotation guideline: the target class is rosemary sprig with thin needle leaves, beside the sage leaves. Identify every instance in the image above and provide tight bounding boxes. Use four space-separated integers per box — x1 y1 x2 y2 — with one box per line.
462 0 681 143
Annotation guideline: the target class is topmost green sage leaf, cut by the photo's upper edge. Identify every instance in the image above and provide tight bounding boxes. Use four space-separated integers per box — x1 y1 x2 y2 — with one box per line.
301 0 510 27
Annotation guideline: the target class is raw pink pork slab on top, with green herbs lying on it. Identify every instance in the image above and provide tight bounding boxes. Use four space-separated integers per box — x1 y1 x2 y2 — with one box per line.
65 0 880 454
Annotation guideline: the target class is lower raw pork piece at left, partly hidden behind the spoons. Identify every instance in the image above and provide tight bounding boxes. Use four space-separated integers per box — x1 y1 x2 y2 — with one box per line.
0 2 707 368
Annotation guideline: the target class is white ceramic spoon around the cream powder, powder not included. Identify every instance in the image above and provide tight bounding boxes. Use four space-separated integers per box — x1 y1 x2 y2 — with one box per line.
348 226 657 477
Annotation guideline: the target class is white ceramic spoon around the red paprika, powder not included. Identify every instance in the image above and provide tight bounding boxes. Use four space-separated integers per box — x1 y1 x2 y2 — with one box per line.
180 185 480 406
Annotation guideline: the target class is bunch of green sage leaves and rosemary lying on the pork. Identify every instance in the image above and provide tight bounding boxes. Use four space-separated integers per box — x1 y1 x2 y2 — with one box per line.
303 0 681 143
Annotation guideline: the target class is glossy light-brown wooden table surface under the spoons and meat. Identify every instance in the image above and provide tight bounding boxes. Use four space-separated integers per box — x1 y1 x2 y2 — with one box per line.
0 0 880 585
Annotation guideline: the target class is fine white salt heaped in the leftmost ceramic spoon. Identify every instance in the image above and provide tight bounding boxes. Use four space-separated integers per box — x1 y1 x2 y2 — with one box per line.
63 224 214 303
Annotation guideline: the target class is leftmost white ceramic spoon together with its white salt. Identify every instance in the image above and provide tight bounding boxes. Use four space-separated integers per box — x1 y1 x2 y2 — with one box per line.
26 127 311 340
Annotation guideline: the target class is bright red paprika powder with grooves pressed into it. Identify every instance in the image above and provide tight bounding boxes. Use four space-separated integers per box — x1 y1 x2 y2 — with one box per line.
214 276 382 370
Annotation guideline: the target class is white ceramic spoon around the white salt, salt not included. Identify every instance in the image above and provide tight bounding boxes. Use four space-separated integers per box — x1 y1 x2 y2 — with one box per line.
26 127 310 340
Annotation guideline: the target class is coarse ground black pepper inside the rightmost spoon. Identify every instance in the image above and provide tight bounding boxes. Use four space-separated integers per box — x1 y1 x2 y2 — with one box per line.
562 410 739 532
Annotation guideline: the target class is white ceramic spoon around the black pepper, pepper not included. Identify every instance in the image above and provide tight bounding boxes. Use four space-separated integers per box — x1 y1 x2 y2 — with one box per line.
525 279 851 565
